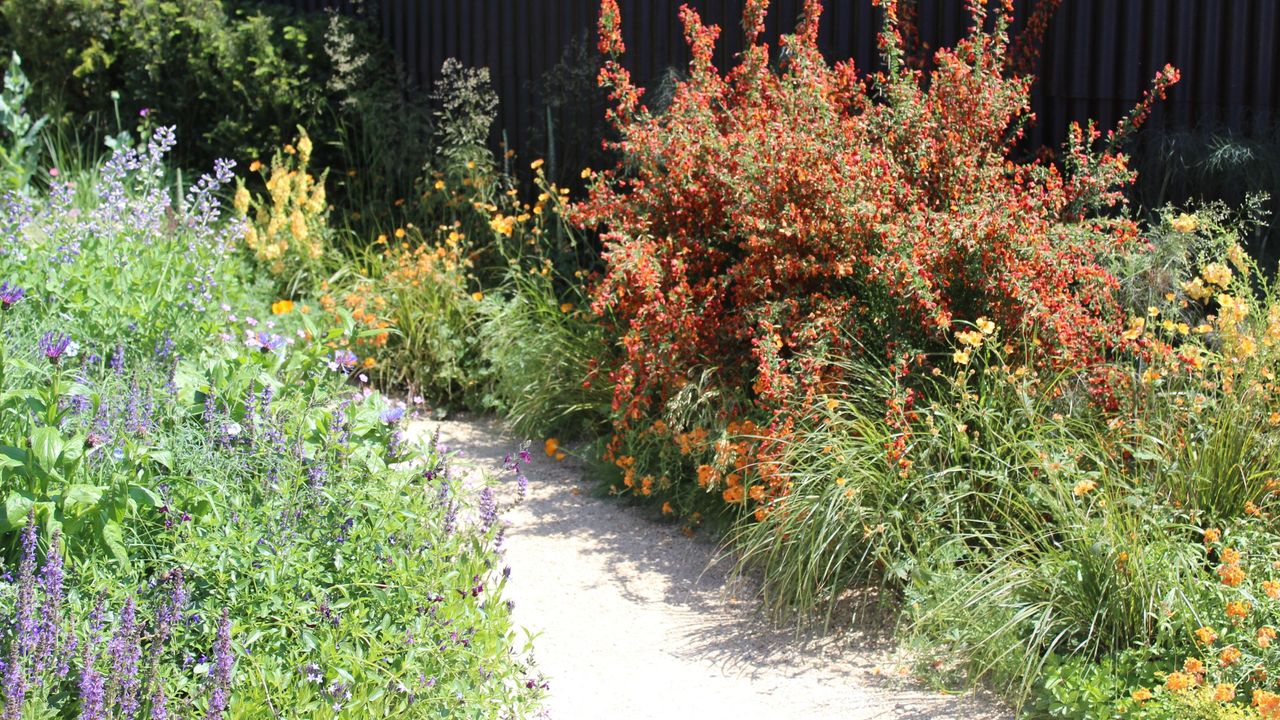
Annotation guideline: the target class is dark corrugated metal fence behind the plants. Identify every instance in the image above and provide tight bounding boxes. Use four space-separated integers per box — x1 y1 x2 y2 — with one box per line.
276 0 1280 161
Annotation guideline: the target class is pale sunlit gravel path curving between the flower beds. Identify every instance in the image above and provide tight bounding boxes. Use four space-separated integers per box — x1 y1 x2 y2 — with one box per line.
413 419 1010 720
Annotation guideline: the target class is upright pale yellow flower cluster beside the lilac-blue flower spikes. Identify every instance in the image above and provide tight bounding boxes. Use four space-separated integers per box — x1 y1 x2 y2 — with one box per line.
232 132 329 275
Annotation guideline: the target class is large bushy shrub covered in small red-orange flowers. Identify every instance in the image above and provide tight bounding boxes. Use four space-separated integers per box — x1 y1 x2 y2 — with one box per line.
576 0 1178 504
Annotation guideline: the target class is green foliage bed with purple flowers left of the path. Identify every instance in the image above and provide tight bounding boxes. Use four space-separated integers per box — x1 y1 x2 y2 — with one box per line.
0 129 544 719
